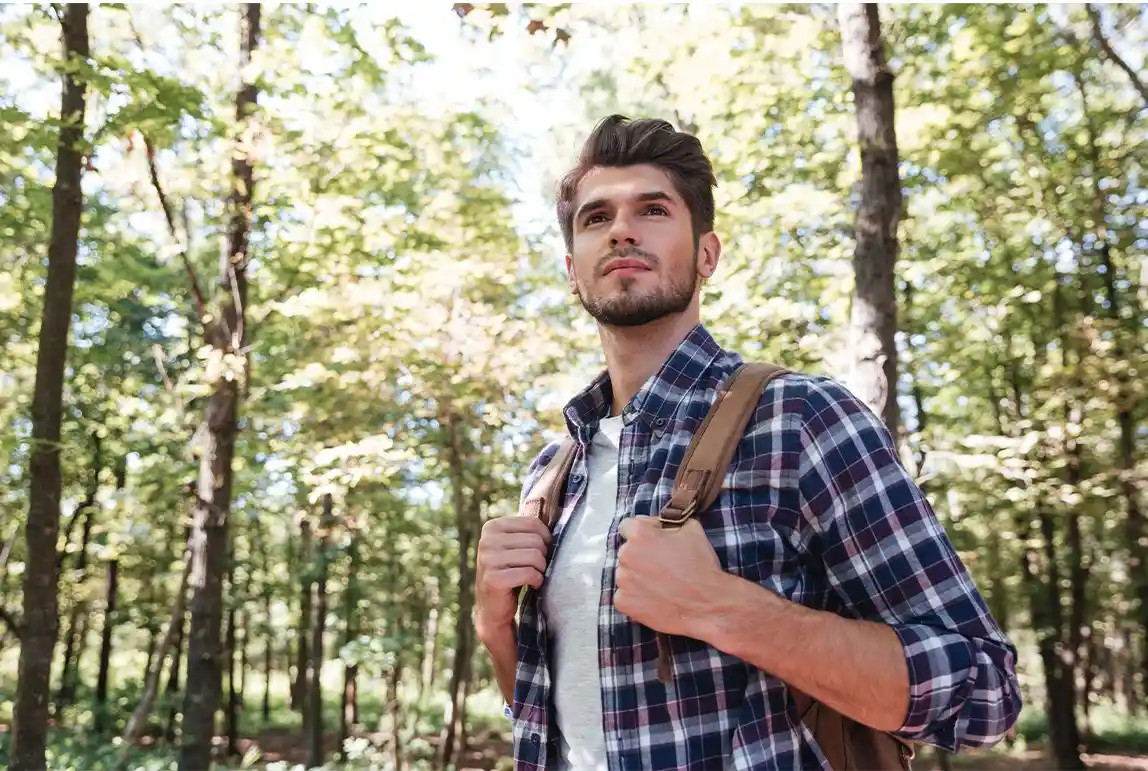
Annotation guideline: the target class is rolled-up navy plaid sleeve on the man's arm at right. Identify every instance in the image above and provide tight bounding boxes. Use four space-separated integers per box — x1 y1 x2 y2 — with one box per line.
798 377 1022 751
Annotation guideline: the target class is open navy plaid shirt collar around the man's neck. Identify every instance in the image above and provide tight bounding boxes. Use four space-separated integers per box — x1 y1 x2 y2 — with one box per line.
563 324 724 441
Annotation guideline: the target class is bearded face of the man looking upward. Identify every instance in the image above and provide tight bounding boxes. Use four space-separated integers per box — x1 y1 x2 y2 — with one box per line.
566 165 718 327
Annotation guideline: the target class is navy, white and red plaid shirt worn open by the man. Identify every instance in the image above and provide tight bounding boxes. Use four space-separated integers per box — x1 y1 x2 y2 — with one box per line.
509 325 1021 771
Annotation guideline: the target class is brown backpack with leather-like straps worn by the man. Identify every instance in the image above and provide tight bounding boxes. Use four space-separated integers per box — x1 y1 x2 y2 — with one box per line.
521 364 914 771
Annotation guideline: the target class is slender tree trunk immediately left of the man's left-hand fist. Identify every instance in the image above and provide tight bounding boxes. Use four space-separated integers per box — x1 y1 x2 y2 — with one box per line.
439 413 474 769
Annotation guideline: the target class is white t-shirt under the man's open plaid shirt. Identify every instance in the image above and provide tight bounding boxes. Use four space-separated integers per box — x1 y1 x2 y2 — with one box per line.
541 416 622 771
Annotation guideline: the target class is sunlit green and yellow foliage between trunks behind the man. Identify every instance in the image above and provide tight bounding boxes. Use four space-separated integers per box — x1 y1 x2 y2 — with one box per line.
0 3 1148 769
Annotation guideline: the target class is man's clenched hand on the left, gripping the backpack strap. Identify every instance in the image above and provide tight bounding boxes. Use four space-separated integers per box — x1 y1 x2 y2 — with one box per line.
474 516 550 639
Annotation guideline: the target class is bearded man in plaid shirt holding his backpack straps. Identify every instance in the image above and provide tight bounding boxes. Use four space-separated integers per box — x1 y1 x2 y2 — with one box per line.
475 116 1021 771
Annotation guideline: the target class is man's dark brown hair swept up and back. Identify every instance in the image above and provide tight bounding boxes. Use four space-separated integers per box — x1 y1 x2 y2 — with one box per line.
558 115 718 251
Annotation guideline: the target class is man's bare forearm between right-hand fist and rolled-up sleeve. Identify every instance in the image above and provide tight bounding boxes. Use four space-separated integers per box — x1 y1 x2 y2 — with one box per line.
703 574 909 731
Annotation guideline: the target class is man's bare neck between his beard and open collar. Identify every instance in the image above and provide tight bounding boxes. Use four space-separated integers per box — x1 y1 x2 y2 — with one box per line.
598 312 698 415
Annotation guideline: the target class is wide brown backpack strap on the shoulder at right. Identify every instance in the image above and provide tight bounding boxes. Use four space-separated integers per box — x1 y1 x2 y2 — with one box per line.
659 364 789 528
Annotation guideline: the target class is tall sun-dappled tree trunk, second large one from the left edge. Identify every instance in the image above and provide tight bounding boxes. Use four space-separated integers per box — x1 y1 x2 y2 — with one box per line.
179 3 259 771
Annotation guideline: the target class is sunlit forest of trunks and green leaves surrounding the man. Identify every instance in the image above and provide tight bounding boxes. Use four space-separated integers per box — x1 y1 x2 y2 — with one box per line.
0 3 1148 771
